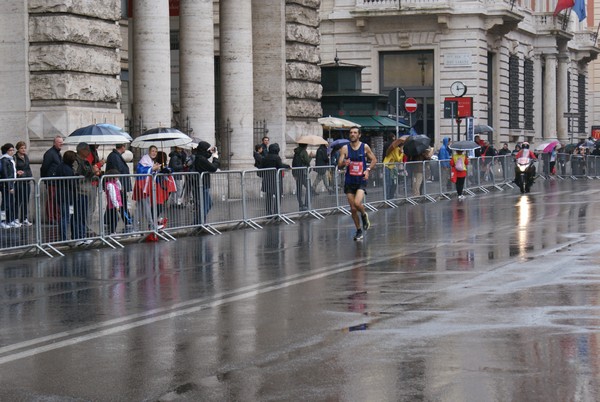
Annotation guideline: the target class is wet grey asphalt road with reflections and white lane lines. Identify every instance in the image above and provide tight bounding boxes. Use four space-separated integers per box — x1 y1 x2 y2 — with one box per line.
0 180 600 401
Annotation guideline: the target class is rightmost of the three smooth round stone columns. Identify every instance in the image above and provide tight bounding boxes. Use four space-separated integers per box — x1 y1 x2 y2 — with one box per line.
219 0 254 170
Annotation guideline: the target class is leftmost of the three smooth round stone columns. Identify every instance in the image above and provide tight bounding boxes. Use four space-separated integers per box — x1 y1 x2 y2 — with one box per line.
131 0 172 135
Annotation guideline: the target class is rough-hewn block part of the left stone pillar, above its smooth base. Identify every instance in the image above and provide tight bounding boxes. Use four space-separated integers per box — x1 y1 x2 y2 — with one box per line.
29 0 121 106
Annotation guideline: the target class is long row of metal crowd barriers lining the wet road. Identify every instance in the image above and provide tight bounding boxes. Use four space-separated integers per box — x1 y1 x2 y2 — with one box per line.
0 154 600 257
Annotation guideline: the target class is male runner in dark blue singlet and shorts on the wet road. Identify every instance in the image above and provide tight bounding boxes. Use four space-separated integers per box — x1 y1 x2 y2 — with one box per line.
338 127 377 240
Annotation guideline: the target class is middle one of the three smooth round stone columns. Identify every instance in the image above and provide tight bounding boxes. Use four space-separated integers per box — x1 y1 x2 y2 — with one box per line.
179 0 215 144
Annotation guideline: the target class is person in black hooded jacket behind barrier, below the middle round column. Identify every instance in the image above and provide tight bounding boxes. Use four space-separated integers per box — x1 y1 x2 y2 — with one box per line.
194 141 221 225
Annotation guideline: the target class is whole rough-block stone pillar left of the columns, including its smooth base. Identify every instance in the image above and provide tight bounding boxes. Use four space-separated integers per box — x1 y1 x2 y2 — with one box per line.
27 0 123 155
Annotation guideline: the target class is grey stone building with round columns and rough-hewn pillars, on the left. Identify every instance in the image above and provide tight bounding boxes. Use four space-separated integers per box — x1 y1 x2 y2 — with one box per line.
0 0 322 168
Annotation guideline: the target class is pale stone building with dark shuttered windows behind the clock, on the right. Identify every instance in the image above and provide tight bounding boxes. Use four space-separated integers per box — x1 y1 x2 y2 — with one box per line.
320 0 600 148
